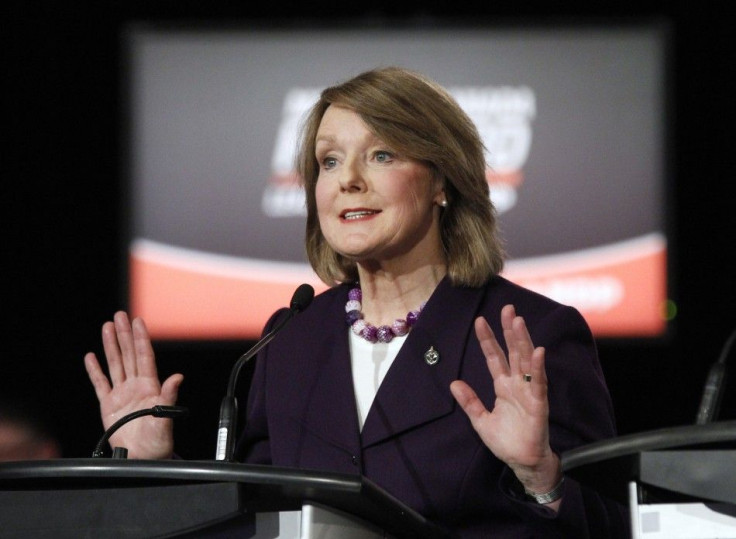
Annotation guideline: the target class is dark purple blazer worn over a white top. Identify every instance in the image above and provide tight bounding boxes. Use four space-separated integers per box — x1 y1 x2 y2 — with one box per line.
237 277 629 539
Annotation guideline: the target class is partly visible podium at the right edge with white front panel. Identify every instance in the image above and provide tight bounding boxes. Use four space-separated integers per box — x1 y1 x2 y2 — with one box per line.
561 421 736 539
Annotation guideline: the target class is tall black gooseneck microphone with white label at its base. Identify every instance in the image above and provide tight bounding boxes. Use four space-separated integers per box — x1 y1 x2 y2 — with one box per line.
215 283 314 462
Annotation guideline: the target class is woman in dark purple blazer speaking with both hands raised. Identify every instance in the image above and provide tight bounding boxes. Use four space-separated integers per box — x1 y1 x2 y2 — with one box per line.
86 68 627 539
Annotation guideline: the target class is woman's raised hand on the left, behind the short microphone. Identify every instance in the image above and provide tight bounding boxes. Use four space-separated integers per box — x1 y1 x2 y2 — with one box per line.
84 311 184 459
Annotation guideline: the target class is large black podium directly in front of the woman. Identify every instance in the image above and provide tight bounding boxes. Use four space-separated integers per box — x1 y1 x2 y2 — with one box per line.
0 458 452 539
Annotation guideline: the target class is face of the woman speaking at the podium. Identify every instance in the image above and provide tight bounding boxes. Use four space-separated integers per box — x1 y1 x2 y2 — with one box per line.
315 105 444 272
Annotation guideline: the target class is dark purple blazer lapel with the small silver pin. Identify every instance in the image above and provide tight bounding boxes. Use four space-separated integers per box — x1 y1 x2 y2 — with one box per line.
360 278 484 447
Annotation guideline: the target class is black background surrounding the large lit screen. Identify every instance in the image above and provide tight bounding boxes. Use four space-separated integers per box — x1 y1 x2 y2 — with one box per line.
7 0 736 458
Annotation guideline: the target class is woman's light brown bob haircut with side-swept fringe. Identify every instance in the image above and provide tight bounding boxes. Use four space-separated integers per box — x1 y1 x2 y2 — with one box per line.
296 67 505 286
